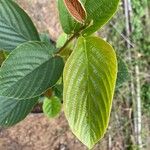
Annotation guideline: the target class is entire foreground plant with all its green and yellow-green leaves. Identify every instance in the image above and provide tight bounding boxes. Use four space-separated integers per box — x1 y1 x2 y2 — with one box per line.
0 0 124 148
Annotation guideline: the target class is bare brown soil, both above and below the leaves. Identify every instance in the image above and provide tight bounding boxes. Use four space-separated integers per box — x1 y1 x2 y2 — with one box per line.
0 0 108 150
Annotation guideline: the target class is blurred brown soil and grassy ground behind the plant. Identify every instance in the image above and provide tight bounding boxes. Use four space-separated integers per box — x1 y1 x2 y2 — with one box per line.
0 0 150 150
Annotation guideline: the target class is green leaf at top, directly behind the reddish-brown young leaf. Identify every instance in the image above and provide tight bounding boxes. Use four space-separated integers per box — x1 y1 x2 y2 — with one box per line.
58 0 119 35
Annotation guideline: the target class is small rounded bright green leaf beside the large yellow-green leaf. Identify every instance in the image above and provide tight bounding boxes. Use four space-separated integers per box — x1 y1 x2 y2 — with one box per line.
43 97 61 118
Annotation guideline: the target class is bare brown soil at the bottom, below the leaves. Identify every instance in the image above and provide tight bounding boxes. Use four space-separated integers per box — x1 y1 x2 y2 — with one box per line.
0 113 107 150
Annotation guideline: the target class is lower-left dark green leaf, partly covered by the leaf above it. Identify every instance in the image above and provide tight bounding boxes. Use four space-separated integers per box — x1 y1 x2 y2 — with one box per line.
0 96 38 127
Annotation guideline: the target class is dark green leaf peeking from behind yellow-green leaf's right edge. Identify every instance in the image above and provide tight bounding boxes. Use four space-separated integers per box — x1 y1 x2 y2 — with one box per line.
116 57 130 89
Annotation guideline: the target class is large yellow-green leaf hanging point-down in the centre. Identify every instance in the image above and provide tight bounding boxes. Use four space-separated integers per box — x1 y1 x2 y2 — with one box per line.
63 37 117 148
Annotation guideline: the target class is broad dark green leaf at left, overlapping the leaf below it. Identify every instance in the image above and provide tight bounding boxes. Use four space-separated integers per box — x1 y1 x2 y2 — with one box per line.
0 42 64 99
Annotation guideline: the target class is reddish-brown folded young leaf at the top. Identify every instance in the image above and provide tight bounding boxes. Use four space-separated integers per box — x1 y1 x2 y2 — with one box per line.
64 0 86 23
